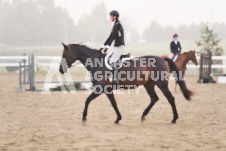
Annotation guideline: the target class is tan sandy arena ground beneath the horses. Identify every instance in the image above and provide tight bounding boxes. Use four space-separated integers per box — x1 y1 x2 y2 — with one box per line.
0 74 226 151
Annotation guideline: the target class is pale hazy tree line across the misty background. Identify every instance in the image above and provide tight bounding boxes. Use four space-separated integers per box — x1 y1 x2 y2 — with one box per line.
0 0 226 46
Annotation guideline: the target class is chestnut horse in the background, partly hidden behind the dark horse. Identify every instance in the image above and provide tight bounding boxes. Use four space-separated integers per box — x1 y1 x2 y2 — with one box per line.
162 50 198 91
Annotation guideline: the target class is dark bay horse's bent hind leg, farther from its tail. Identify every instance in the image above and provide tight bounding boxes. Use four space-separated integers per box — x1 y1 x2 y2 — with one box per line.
141 81 159 121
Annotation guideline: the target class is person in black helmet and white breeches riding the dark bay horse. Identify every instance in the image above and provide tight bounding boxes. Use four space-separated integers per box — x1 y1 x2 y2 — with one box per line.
100 10 125 84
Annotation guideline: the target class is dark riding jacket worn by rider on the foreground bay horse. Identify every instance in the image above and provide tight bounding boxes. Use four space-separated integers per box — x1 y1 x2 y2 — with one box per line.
104 21 125 47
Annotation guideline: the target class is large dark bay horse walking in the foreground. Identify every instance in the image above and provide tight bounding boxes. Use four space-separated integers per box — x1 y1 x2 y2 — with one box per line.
59 44 192 124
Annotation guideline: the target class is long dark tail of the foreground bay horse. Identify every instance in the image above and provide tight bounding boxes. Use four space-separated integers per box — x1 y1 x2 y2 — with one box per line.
164 58 193 100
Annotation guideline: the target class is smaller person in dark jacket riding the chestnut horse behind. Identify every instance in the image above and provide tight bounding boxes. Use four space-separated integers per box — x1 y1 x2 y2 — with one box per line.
170 34 181 62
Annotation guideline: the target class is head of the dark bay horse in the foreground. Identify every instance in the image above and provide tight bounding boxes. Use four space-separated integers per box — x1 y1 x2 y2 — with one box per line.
59 43 77 74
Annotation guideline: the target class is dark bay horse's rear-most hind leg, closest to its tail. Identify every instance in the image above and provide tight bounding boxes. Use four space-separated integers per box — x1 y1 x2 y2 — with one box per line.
157 81 178 123
